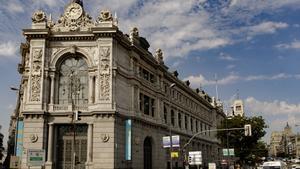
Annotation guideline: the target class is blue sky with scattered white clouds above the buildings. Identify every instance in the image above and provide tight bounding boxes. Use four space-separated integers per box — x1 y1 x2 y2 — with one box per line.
0 0 300 147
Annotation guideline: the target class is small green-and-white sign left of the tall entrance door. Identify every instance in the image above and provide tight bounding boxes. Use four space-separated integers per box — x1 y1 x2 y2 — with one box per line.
27 149 45 166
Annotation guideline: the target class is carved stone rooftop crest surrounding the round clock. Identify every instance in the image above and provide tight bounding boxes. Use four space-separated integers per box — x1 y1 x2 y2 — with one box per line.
52 2 94 32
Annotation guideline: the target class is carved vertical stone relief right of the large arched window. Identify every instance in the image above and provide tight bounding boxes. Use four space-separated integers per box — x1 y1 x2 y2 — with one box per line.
99 47 111 100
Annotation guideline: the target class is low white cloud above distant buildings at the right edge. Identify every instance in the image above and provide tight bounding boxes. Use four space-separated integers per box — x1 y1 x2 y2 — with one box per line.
245 97 300 116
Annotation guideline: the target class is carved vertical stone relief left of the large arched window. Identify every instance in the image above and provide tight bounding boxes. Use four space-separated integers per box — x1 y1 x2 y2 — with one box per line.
30 49 43 102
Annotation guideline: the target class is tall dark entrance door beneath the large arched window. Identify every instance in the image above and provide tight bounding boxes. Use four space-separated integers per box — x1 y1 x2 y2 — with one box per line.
56 125 87 169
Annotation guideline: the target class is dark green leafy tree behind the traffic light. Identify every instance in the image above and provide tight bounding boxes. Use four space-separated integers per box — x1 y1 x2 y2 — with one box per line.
217 116 267 164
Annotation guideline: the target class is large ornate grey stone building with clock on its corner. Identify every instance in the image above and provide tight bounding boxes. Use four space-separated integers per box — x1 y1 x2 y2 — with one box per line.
12 1 225 169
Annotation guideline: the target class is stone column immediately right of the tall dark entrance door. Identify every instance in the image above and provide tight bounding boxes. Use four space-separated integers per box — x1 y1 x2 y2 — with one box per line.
86 123 93 169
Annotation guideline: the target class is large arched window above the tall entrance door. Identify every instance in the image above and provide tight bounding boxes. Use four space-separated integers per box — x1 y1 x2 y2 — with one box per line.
58 56 88 105
